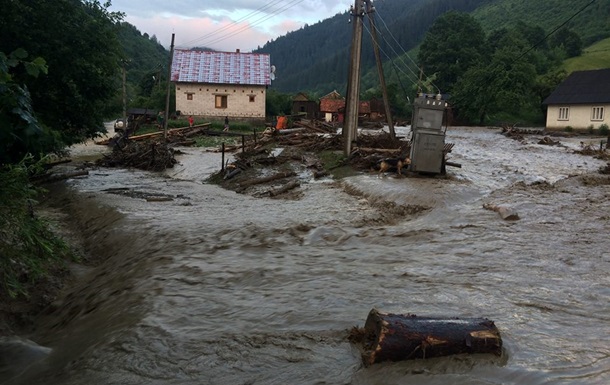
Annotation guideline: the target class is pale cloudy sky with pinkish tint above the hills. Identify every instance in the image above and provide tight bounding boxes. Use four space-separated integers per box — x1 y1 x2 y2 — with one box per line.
110 0 354 52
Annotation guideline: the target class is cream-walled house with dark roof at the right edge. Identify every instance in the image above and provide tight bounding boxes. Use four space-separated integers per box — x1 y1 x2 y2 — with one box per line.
543 68 610 130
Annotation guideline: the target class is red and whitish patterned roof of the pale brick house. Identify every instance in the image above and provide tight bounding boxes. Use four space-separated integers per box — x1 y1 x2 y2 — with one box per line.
172 49 271 85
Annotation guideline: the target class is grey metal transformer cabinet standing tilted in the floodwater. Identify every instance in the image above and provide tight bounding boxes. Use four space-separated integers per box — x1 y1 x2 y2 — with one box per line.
409 95 447 174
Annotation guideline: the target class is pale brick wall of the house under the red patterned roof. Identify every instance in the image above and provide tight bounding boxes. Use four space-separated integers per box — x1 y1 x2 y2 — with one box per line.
176 83 267 119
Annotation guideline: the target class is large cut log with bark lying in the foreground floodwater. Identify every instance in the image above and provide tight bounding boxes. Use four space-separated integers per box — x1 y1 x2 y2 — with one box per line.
351 309 502 366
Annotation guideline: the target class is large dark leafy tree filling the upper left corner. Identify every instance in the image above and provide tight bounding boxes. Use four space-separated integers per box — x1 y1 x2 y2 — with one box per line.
0 0 122 145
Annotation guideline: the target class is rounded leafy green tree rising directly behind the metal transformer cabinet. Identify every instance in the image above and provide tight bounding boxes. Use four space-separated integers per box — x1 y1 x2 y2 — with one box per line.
418 12 486 92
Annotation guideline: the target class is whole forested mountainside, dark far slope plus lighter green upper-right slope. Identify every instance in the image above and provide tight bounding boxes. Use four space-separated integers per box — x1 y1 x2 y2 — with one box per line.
258 0 610 97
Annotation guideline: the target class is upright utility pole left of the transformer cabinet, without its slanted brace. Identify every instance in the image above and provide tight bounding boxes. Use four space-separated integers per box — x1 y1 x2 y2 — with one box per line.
343 0 364 156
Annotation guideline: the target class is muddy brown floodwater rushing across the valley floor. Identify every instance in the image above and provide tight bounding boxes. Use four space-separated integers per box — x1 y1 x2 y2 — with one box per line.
5 128 610 385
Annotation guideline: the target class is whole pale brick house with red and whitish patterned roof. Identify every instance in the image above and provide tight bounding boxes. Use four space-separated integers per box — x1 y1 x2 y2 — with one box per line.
171 49 271 120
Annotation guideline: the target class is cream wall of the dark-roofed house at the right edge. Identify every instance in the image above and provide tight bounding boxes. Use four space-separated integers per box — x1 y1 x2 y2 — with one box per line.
546 104 610 130
